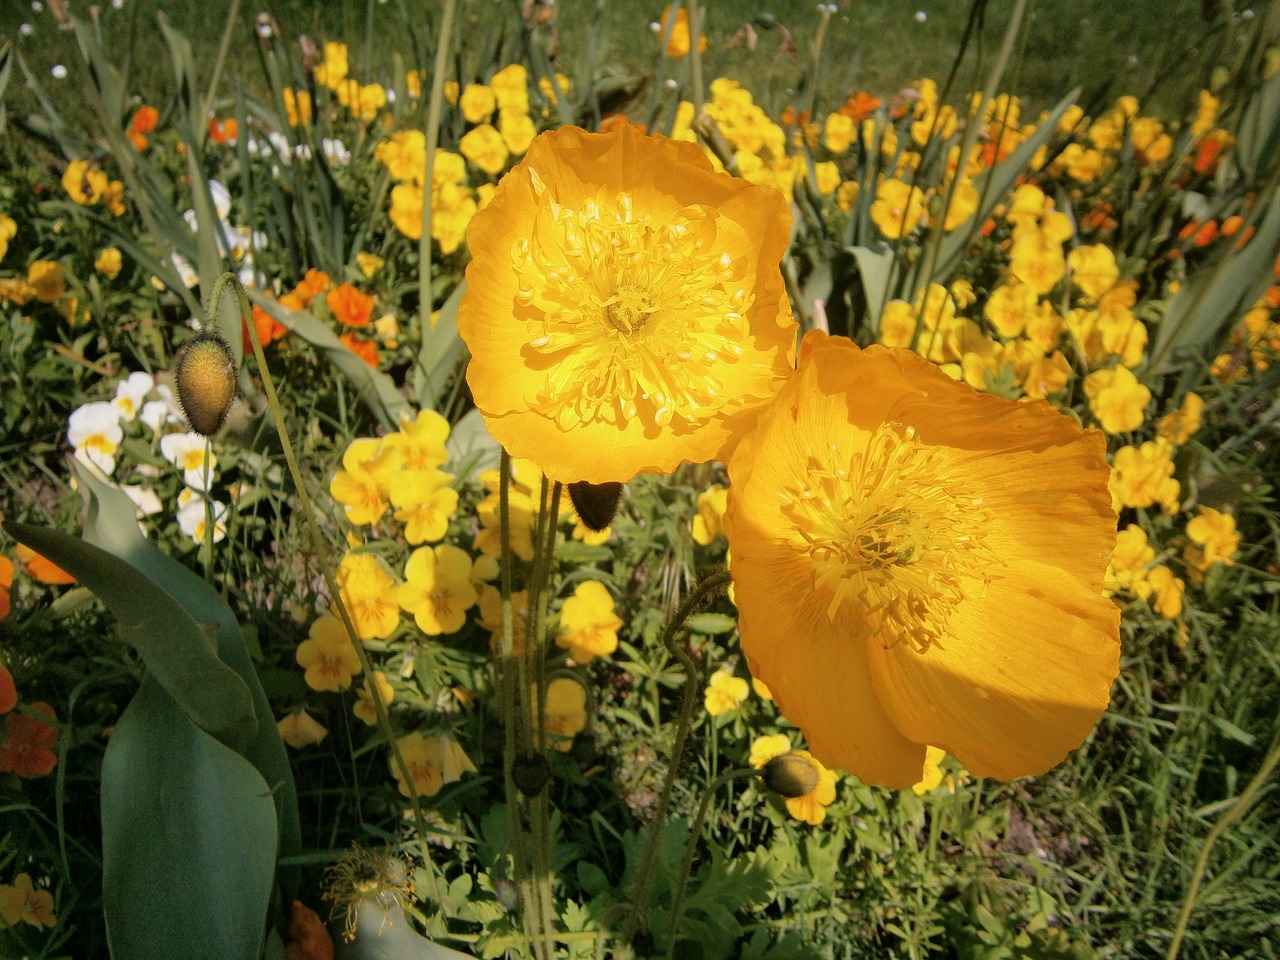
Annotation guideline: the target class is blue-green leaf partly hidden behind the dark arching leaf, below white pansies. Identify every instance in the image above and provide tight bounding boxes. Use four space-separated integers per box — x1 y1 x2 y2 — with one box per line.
76 470 302 880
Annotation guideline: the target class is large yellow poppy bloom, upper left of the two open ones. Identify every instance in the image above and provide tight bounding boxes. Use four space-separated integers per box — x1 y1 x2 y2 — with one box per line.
458 124 795 483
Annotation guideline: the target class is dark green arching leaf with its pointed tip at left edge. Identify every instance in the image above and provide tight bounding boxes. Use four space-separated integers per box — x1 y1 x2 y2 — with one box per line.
5 522 257 750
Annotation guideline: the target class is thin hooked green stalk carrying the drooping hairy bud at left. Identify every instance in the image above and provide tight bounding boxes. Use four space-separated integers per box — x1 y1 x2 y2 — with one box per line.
225 273 445 911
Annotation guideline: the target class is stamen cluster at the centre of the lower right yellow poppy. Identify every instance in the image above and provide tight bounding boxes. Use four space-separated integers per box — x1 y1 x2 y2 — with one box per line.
782 424 1000 653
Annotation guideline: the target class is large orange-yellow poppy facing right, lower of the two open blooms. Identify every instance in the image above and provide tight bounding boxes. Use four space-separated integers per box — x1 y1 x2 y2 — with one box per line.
724 332 1120 788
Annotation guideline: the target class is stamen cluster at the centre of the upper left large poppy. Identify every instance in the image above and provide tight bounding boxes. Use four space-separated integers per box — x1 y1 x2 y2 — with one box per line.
512 170 754 429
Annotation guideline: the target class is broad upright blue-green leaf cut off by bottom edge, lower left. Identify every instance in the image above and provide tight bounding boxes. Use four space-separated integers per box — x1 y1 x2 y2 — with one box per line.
102 675 278 960
